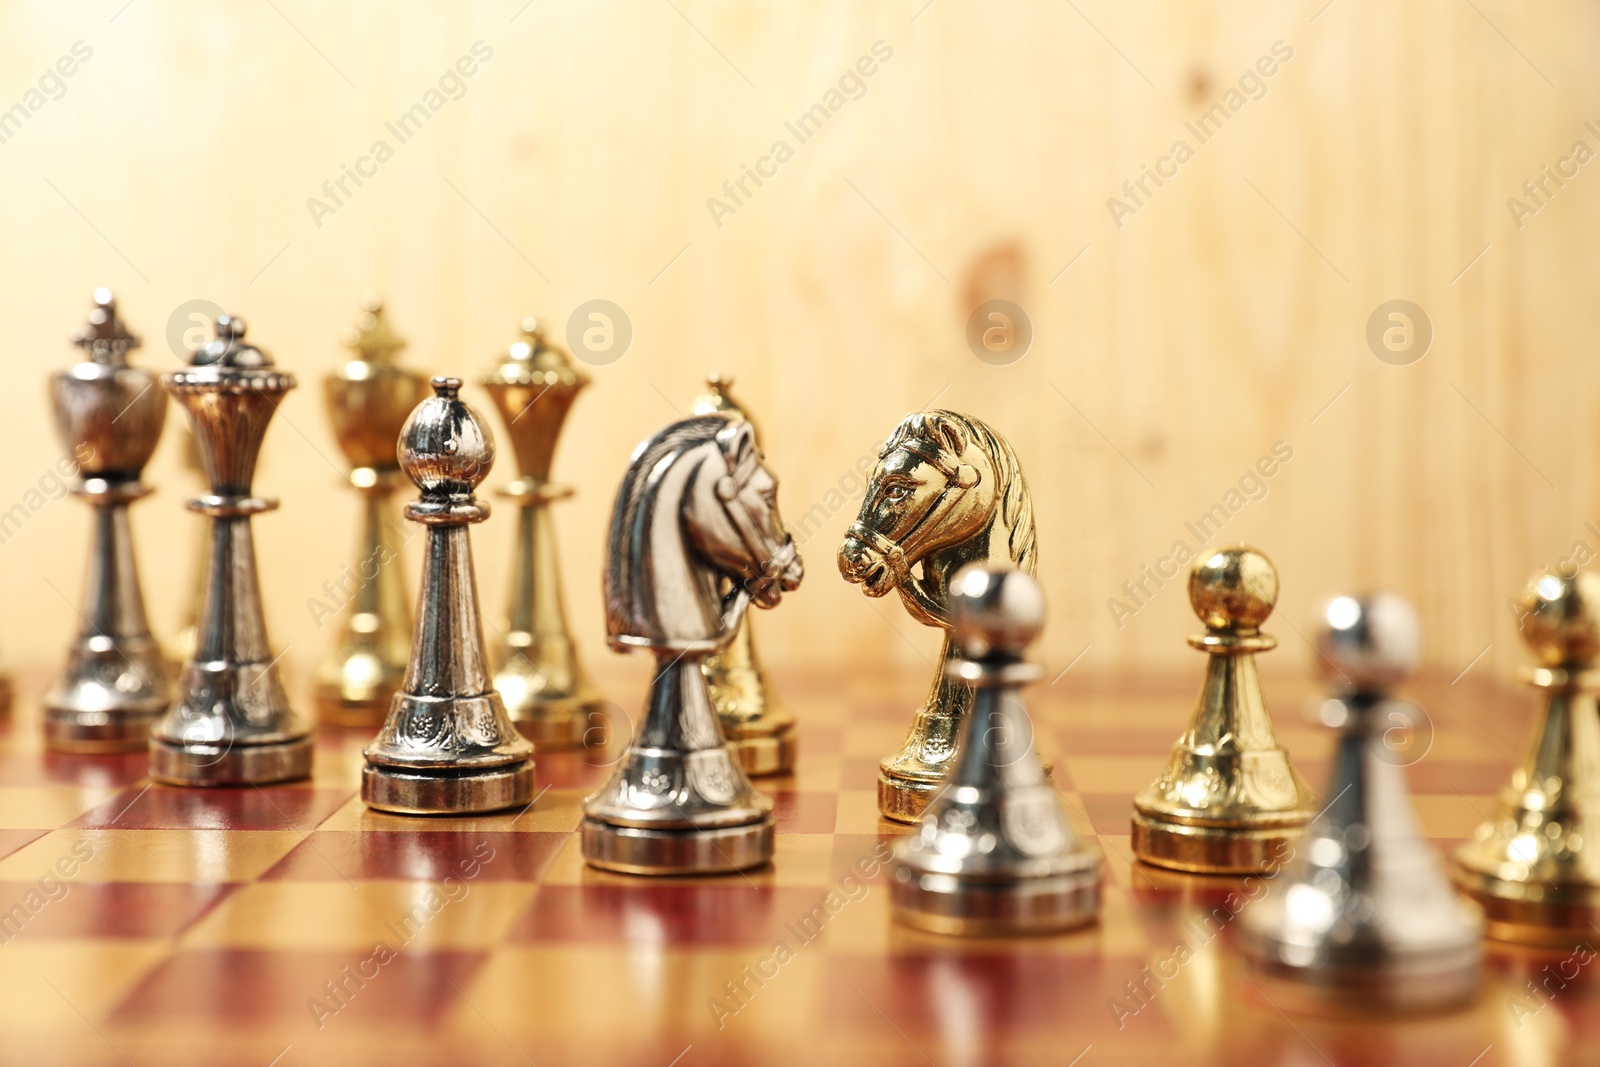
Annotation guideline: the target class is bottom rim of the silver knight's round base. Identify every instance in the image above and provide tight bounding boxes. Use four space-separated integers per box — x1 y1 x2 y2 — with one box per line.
581 816 774 875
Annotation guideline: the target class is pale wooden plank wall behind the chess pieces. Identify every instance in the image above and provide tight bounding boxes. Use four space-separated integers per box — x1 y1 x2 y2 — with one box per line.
0 0 1600 697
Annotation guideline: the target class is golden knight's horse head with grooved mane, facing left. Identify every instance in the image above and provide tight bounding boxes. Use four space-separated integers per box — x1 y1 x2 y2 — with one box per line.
838 411 1034 622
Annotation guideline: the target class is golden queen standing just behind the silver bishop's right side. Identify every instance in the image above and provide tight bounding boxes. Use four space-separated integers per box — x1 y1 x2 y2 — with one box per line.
478 318 606 752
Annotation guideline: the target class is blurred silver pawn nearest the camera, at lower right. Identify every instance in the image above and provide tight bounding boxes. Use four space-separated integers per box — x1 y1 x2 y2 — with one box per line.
1240 593 1482 1013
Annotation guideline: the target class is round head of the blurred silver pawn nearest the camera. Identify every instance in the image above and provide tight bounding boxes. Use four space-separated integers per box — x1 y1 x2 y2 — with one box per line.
1315 593 1422 696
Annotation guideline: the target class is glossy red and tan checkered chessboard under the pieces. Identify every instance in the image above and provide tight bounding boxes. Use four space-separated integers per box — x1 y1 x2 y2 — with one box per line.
0 657 1580 1067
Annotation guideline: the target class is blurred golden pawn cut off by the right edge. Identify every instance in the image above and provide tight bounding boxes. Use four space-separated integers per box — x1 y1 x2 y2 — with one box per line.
1454 571 1600 949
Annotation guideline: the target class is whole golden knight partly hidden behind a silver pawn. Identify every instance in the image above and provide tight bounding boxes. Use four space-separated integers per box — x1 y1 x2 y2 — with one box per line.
838 411 1048 822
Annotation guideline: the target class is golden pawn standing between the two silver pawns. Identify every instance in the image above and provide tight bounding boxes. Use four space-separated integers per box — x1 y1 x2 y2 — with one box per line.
1133 544 1315 873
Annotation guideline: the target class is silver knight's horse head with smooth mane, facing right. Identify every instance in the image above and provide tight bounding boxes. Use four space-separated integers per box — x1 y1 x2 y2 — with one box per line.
605 414 803 651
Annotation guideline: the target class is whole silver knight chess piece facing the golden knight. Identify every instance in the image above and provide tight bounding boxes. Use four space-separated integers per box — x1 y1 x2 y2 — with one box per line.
581 416 803 875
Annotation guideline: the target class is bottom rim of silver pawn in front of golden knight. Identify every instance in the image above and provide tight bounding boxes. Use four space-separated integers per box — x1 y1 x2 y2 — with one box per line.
890 862 1101 937
